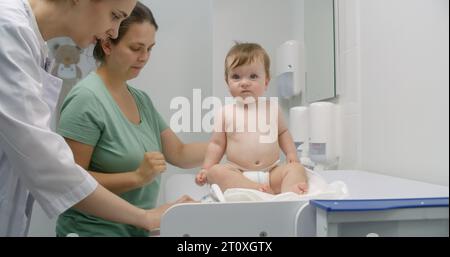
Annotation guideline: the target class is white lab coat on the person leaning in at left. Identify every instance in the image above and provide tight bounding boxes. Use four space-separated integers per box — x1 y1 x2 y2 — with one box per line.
0 0 97 236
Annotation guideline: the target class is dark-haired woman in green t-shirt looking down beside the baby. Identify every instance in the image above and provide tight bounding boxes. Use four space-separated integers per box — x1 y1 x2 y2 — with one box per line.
56 2 206 236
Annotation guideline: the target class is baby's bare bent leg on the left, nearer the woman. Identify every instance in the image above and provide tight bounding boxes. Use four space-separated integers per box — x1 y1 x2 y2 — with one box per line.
206 164 272 193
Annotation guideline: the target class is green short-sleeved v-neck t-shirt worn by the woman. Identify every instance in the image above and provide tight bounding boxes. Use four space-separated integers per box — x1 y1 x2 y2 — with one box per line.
56 72 168 236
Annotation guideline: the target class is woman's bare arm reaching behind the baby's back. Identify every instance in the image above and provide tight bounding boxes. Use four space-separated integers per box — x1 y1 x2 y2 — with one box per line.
161 128 208 169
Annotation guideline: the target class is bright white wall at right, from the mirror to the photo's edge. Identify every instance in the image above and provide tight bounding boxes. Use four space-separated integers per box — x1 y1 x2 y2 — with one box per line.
338 0 449 185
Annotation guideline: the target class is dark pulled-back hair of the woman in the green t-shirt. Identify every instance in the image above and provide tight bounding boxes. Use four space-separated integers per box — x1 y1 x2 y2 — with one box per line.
93 1 158 63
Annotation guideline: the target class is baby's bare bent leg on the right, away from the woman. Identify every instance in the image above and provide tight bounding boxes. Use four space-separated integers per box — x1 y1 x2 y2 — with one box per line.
270 163 308 194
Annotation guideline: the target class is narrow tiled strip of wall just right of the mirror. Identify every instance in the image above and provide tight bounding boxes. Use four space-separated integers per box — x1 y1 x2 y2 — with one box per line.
336 0 361 169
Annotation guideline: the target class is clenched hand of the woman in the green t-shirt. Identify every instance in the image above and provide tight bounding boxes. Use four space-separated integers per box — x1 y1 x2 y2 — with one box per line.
135 152 166 185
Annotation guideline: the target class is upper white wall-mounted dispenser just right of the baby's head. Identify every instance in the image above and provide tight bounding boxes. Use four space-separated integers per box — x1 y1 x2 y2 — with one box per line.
276 40 305 99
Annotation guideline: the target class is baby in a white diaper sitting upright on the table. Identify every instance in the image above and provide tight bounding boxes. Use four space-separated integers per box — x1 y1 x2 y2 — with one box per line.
195 43 308 194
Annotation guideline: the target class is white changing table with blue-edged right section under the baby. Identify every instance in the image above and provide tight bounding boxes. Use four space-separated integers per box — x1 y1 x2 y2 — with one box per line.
160 170 449 237
